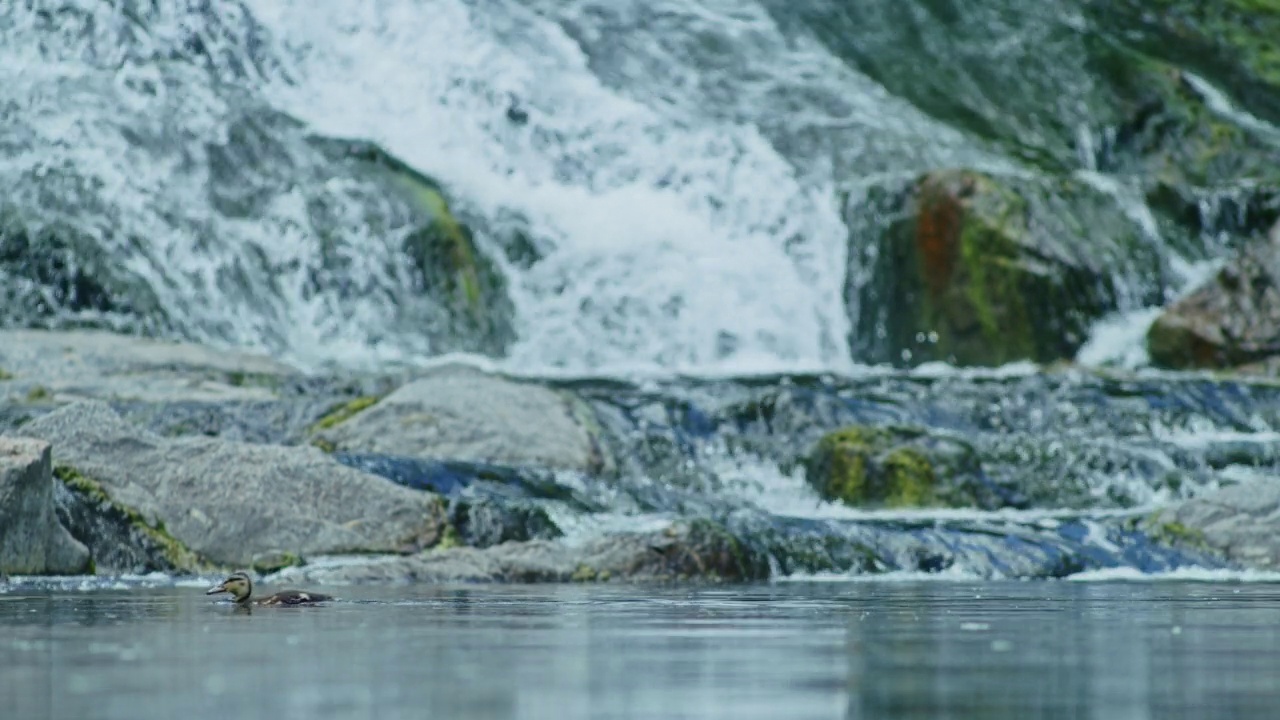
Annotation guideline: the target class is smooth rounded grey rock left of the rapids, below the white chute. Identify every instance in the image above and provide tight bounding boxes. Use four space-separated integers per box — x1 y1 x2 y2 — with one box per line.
309 365 607 473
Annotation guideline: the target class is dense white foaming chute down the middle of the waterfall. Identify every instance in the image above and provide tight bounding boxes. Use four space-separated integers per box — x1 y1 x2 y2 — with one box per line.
241 0 847 374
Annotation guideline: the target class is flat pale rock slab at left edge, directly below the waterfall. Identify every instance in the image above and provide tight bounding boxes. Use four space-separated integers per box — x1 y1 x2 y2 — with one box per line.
0 331 301 402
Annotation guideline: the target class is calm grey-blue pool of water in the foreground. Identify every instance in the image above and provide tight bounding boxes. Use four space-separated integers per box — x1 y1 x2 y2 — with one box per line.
0 582 1280 720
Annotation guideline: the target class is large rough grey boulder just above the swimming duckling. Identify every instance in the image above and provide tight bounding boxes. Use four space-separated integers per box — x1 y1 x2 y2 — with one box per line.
24 402 443 566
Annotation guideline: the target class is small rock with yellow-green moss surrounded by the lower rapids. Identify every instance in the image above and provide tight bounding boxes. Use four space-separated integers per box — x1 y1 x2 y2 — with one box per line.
805 425 993 507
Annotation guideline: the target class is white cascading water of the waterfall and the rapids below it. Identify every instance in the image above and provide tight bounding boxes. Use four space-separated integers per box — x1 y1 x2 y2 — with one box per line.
0 0 1275 576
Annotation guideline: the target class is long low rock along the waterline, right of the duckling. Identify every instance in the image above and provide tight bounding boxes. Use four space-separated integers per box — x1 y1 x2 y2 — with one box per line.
276 520 769 583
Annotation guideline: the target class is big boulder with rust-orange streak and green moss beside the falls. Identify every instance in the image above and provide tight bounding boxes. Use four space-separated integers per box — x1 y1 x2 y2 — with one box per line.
846 170 1164 366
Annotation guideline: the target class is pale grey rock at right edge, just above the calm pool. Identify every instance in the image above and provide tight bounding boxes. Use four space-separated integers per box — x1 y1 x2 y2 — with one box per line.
1147 480 1280 570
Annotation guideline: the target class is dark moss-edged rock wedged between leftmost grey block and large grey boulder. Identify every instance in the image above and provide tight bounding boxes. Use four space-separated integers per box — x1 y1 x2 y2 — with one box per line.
54 465 210 573
